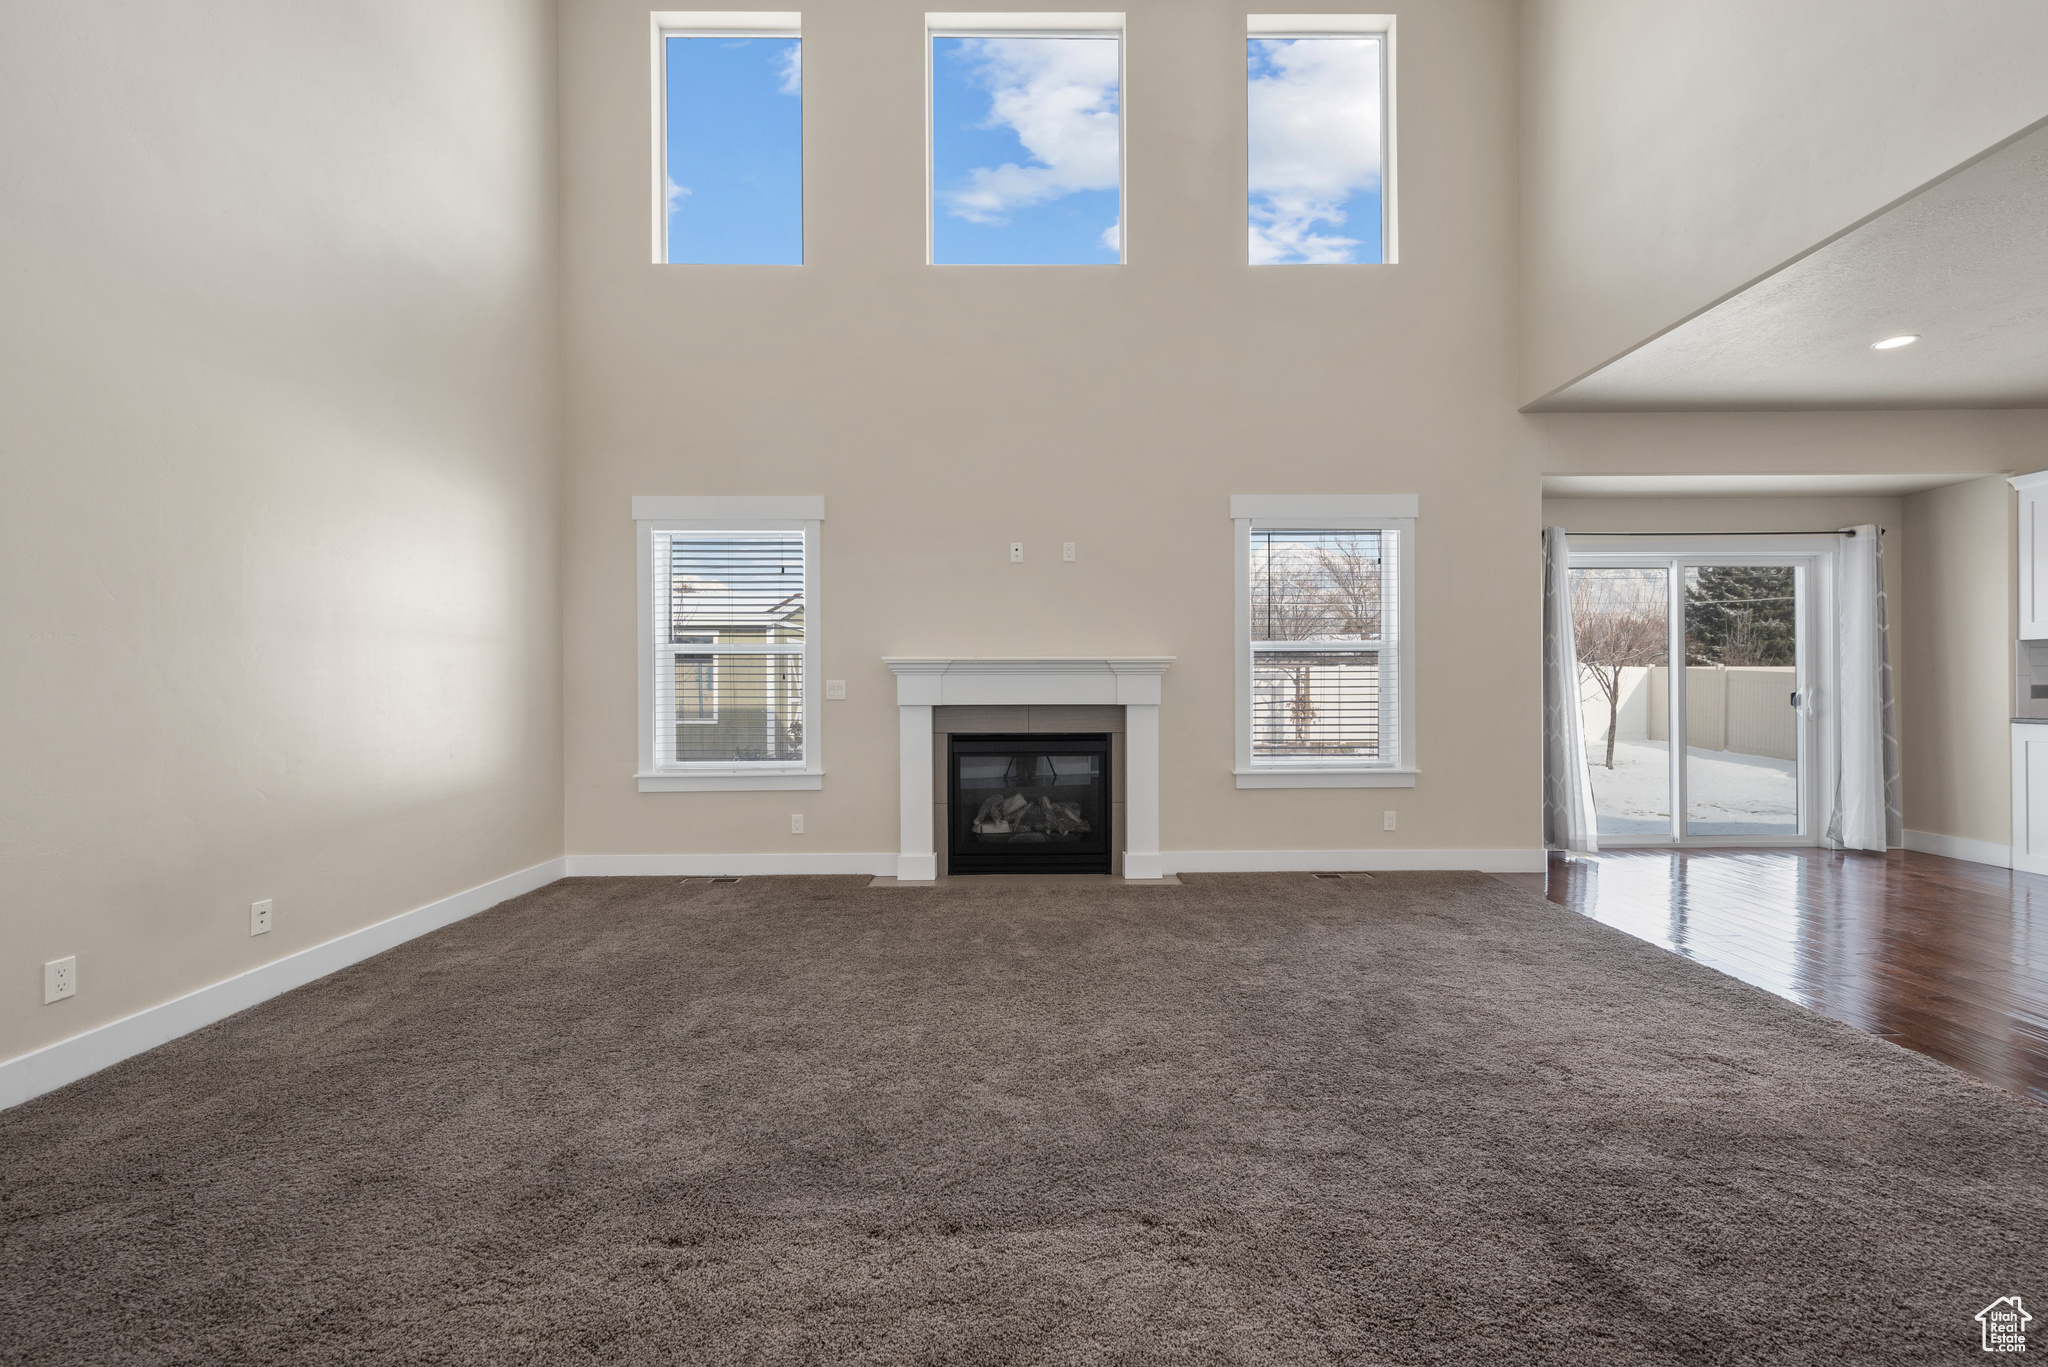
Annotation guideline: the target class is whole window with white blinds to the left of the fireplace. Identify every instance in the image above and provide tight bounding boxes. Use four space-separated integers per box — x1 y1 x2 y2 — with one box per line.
635 498 819 791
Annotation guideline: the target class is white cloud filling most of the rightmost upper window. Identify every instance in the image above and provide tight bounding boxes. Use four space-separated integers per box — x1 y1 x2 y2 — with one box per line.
1247 39 1380 264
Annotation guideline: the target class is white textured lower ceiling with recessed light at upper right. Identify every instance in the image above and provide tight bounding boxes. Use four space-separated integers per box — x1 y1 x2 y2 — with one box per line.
1528 127 2048 412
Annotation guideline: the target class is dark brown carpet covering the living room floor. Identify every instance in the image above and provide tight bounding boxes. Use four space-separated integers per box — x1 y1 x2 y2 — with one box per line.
0 875 2048 1365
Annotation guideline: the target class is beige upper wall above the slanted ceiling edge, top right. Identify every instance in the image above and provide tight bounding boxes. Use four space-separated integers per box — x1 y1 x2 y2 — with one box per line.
1523 0 2048 400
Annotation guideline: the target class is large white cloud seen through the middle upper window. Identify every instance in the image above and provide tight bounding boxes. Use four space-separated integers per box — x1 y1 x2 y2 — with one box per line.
940 39 1118 223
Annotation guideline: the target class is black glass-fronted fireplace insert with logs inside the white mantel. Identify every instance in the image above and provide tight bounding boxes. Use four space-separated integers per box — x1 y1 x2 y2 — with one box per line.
946 732 1110 873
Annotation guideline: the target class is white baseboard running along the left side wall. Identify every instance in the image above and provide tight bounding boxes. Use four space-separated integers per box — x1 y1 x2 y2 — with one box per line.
0 859 563 1111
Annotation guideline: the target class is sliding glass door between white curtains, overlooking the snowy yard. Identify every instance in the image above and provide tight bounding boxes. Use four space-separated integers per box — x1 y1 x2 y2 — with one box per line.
1571 537 1831 844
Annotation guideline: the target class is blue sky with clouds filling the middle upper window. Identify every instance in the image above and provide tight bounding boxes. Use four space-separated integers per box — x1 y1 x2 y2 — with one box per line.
932 37 1122 264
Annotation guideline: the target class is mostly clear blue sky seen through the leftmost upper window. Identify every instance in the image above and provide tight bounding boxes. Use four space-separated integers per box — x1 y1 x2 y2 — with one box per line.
666 37 803 266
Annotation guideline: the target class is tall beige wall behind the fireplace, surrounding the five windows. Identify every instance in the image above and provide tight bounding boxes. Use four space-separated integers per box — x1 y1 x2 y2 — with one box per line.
563 0 1540 853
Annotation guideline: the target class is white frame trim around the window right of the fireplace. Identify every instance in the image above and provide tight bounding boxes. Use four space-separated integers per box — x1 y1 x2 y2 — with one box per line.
1231 494 1421 787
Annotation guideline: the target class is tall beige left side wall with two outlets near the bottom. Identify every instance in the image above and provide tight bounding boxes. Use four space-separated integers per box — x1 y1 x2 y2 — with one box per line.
0 0 561 1060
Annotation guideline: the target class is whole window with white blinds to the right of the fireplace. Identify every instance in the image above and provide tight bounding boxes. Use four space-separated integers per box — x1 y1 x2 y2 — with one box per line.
1237 498 1413 787
